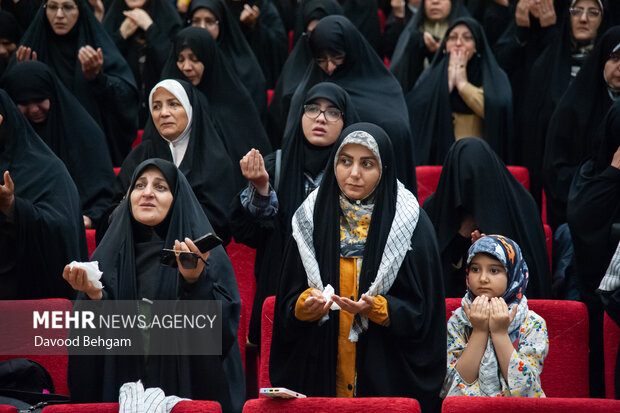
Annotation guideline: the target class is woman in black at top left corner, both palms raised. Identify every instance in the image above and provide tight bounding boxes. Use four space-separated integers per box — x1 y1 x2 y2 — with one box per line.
16 0 139 166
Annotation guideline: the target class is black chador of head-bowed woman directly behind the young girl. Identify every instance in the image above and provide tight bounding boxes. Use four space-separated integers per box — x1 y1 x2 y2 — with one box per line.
424 138 551 298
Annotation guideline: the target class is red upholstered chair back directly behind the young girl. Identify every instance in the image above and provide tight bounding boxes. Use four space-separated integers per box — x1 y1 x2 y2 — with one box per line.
446 298 590 398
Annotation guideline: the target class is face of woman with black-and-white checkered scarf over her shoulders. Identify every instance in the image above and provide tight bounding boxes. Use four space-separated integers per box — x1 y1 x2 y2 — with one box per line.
336 143 381 200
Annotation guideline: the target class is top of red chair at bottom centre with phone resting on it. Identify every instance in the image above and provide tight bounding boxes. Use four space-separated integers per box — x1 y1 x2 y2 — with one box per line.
243 397 422 413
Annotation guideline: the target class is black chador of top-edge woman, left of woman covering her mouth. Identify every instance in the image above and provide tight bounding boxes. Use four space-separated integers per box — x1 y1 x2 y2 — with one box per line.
390 0 469 93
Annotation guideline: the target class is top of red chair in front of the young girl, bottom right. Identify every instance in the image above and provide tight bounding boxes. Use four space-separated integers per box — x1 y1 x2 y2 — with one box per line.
441 394 620 413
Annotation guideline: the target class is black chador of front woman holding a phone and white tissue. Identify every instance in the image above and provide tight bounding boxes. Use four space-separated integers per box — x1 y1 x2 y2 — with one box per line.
68 159 245 412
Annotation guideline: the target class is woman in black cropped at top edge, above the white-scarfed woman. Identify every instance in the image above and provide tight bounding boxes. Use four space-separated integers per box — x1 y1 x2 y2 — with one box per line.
102 0 181 127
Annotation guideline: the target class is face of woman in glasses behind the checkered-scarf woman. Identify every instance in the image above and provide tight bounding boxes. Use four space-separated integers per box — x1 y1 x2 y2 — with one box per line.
301 98 344 146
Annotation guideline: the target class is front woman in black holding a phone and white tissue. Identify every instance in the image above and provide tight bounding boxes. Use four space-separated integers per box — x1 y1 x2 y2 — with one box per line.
62 159 245 412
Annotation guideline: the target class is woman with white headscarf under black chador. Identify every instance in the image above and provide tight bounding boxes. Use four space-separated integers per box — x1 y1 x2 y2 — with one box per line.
115 79 235 244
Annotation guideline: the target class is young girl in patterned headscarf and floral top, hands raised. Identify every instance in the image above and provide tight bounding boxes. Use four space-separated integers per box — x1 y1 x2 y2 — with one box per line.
442 235 549 397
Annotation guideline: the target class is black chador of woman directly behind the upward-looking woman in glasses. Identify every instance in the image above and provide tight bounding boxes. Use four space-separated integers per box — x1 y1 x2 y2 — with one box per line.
272 16 417 194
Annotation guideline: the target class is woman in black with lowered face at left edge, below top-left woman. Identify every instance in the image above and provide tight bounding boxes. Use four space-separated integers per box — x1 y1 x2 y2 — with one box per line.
0 61 115 228
